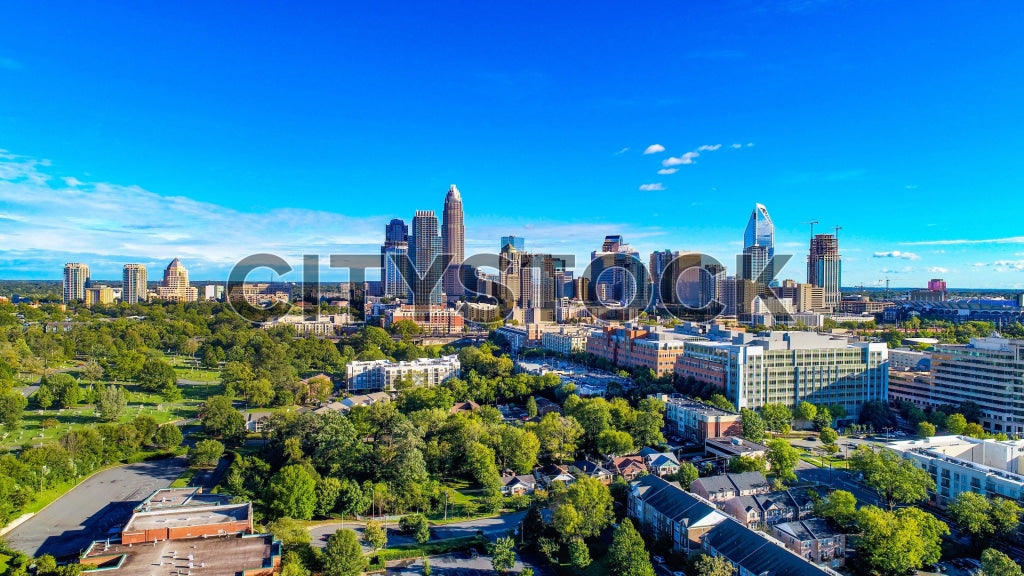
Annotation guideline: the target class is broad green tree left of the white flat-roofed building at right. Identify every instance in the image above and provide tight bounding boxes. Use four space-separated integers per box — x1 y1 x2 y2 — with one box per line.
850 445 935 510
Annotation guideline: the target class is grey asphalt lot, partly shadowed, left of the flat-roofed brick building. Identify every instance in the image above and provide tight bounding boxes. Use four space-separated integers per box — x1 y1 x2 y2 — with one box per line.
4 457 187 558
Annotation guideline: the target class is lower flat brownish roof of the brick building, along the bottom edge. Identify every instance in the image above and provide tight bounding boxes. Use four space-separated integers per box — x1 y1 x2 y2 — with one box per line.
81 535 281 576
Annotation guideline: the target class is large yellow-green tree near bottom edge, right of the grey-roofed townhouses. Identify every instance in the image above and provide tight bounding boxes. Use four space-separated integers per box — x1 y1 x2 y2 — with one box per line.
856 506 949 576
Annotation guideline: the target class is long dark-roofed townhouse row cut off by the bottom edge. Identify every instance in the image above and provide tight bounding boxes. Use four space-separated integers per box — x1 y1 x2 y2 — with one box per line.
701 519 837 576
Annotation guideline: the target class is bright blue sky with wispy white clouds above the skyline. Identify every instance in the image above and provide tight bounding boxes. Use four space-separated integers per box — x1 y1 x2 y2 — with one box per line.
0 0 1024 288
